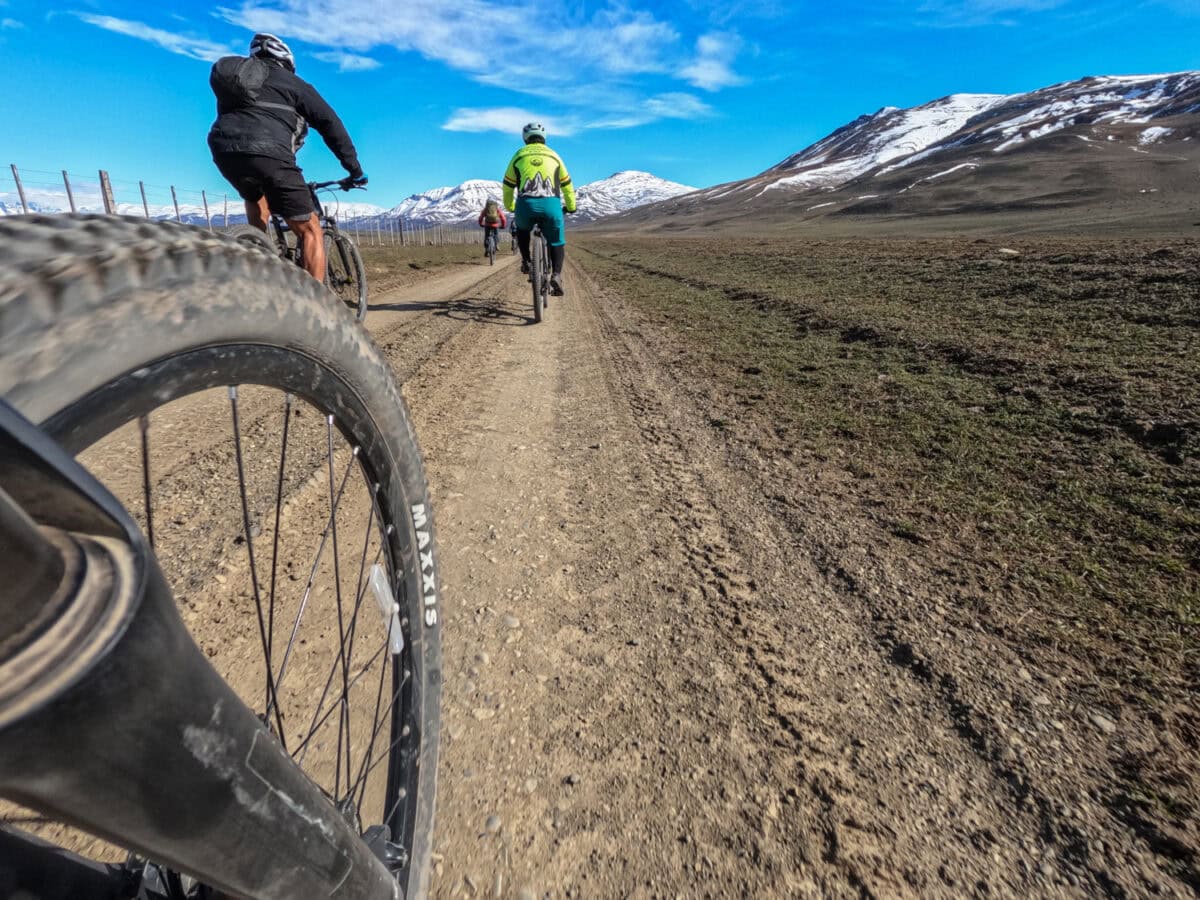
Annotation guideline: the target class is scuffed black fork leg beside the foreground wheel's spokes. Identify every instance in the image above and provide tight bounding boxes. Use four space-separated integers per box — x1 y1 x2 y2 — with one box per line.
0 401 401 900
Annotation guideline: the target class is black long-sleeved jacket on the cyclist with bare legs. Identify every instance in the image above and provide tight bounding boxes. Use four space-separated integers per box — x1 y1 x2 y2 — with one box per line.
209 64 362 178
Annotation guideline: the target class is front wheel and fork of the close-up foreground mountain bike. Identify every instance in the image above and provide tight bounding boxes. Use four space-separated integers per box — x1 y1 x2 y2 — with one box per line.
0 216 442 900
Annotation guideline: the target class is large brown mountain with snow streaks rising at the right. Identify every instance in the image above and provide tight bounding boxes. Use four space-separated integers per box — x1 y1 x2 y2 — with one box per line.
614 72 1200 227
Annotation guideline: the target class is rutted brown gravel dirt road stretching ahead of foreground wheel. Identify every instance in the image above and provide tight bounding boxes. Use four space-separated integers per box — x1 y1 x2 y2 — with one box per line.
368 258 1200 899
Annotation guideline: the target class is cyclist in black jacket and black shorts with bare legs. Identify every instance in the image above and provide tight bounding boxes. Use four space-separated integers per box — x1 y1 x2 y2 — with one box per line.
209 34 367 281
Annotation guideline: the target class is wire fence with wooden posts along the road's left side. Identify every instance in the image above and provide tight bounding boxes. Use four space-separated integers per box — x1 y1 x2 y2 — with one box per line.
0 163 479 247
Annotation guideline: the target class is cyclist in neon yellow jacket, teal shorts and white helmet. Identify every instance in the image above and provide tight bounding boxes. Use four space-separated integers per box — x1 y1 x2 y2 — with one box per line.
504 122 575 296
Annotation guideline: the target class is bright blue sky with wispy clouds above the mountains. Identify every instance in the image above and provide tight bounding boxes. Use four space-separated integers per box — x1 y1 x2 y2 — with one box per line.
0 0 1200 205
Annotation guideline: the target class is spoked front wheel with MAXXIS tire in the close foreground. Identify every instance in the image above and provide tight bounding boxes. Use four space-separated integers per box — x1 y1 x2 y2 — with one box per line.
0 216 442 896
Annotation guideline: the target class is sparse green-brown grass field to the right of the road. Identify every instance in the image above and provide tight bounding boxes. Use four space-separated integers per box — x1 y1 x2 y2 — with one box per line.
575 238 1200 688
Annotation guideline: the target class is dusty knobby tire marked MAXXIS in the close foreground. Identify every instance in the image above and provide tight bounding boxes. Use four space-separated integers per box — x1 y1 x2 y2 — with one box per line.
0 216 442 896
